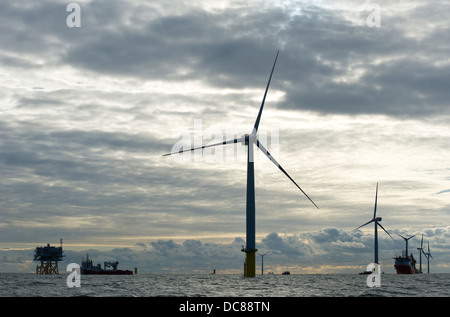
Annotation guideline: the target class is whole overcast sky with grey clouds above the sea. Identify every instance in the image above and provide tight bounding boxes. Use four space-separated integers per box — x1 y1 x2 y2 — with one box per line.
0 0 450 273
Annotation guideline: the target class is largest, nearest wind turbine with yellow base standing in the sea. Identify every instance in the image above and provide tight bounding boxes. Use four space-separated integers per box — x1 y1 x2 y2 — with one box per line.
164 51 319 277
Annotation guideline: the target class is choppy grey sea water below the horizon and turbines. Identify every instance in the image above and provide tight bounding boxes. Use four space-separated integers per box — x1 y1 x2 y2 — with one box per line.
0 273 450 298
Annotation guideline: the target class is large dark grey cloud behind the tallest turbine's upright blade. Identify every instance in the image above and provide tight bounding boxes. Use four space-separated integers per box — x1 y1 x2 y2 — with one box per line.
74 1 448 117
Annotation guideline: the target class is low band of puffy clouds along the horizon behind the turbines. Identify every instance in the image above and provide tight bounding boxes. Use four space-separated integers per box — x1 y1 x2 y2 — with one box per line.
4 228 448 274
